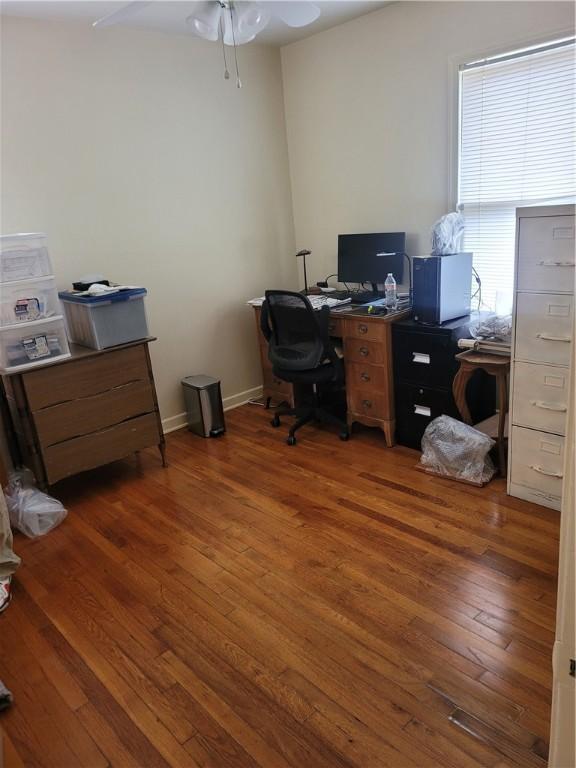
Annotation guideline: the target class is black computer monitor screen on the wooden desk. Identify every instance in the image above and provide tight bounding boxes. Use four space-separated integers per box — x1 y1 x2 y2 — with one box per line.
338 232 406 283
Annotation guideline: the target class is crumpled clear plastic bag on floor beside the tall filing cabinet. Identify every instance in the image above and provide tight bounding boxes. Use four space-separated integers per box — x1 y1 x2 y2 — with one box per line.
420 416 496 484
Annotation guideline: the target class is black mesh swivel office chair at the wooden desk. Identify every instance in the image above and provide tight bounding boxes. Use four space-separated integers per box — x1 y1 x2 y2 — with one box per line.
260 291 350 445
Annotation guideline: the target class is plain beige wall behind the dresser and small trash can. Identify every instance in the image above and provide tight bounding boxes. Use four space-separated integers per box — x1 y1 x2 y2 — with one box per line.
0 18 296 427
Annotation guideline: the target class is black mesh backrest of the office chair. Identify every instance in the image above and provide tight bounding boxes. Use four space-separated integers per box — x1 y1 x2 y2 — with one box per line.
261 291 330 371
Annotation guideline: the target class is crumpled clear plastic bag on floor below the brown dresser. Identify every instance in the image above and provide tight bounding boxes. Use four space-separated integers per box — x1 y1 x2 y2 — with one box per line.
5 469 68 539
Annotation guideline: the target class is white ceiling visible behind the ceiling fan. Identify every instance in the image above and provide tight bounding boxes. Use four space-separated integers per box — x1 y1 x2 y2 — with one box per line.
0 0 390 45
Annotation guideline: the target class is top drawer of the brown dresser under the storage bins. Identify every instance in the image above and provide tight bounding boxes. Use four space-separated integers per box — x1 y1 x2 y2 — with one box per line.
22 345 150 411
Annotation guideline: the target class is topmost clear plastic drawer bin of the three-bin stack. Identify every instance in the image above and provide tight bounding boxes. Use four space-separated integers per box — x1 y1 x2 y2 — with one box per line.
0 234 52 283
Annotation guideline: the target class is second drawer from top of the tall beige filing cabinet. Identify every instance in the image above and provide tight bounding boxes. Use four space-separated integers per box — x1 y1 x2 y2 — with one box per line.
515 293 574 366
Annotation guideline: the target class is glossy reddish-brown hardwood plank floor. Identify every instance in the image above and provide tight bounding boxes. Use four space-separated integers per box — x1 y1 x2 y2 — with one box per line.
0 406 559 768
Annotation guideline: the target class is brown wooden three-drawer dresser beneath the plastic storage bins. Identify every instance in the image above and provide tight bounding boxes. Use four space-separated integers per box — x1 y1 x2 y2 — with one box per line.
3 339 166 486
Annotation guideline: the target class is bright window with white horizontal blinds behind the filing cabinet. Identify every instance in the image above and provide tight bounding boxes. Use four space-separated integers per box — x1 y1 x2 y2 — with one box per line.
458 39 576 309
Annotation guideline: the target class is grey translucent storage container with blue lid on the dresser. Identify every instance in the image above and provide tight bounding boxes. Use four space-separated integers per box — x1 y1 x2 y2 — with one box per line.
58 288 149 349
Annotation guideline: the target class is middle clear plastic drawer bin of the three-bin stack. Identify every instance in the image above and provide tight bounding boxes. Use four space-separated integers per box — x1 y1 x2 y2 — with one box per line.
0 276 62 325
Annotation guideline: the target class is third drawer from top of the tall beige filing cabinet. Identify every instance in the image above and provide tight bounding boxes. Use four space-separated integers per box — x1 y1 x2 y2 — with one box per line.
512 363 569 435
